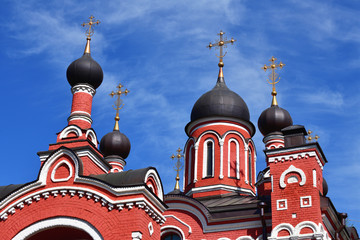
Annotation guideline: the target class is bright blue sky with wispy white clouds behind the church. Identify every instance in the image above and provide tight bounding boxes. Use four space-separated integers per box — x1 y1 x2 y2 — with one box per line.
0 0 360 229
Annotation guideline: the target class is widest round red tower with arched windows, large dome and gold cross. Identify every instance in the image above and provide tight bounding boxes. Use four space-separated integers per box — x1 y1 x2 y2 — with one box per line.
184 31 256 198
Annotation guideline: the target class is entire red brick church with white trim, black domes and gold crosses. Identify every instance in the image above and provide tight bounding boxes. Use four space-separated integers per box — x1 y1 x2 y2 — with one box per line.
0 18 359 240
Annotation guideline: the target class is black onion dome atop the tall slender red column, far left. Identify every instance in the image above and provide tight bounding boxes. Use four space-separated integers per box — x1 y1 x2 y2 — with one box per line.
66 53 104 89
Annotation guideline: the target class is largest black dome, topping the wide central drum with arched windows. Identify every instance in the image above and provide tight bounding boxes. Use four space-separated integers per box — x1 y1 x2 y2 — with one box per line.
191 78 250 122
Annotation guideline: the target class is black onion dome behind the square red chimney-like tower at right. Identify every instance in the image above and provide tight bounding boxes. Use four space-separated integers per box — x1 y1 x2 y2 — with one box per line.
258 105 293 136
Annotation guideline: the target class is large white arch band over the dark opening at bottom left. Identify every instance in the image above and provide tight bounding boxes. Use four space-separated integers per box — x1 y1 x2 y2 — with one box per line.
13 217 103 240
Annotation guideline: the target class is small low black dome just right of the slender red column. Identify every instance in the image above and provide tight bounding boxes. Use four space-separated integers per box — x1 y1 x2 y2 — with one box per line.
100 130 131 159
